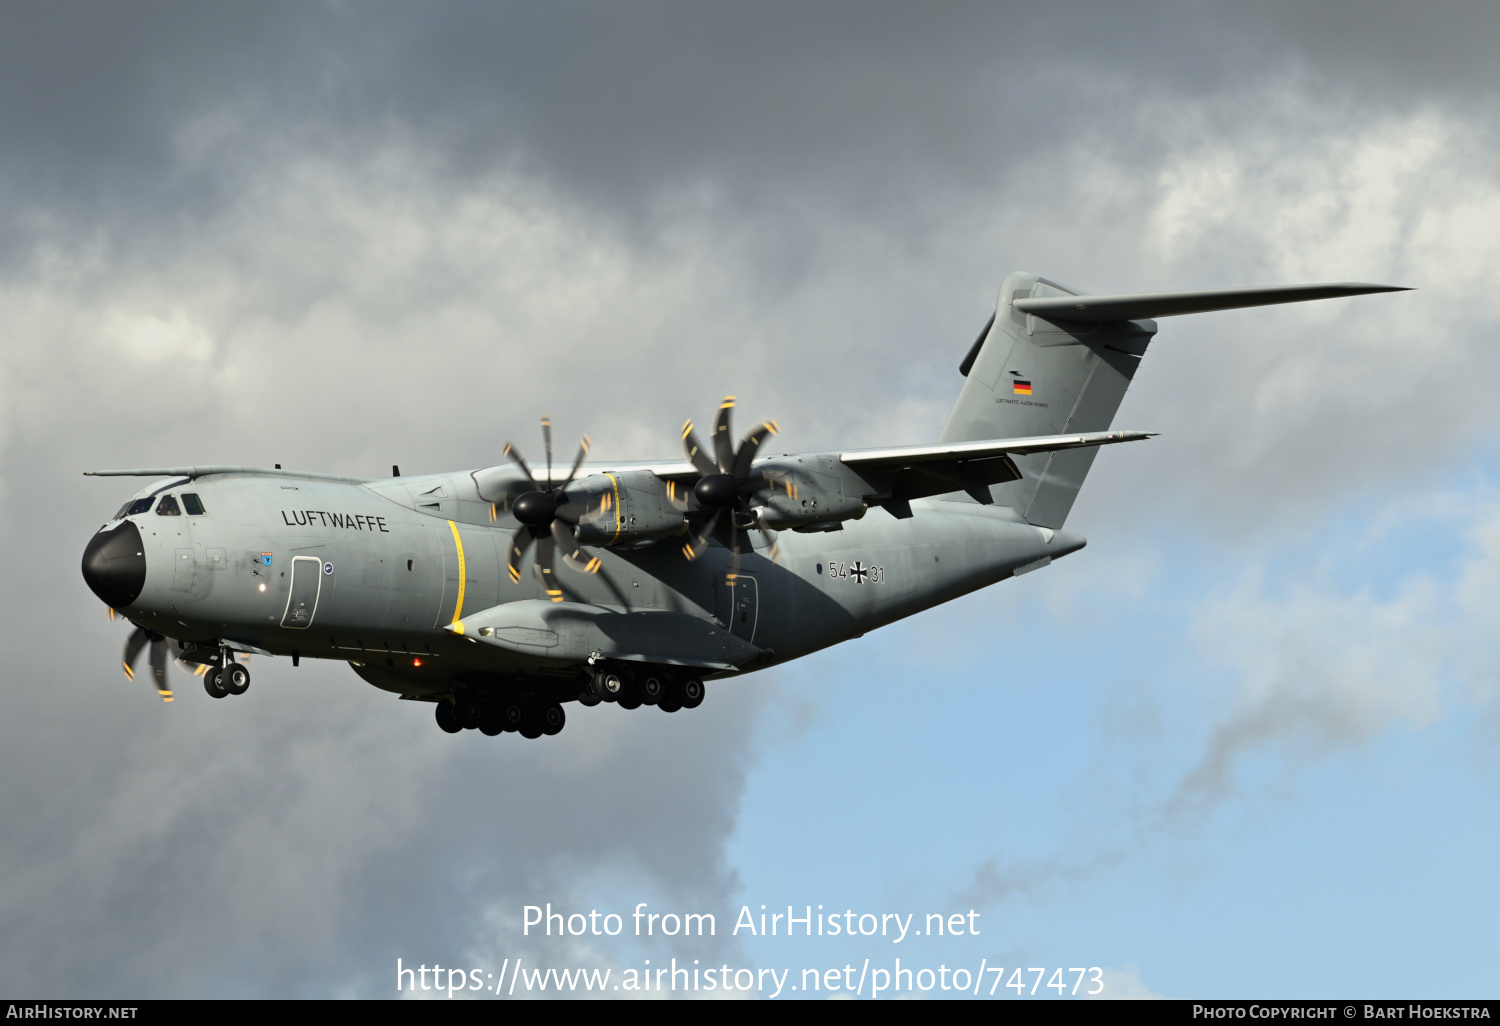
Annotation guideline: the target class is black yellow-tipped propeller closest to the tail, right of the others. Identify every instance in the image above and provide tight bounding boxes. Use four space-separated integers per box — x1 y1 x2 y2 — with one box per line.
668 396 780 588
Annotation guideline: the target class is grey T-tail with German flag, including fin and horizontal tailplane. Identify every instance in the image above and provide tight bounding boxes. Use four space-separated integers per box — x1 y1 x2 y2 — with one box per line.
939 272 1404 530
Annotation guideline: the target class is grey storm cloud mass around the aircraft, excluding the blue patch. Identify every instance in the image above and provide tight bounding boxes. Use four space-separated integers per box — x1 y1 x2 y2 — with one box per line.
0 3 1500 996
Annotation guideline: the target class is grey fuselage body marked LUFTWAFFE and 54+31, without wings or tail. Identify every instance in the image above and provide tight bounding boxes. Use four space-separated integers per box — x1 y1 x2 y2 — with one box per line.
86 473 1083 698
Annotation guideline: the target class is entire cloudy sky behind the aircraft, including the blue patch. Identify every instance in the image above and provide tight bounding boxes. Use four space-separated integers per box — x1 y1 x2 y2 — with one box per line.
0 0 1500 998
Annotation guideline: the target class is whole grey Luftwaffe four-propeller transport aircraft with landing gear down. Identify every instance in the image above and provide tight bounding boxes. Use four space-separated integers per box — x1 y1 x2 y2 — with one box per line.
83 273 1401 738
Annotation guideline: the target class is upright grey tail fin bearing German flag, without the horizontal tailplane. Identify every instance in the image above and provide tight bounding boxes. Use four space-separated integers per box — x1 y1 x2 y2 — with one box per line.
939 272 1157 528
